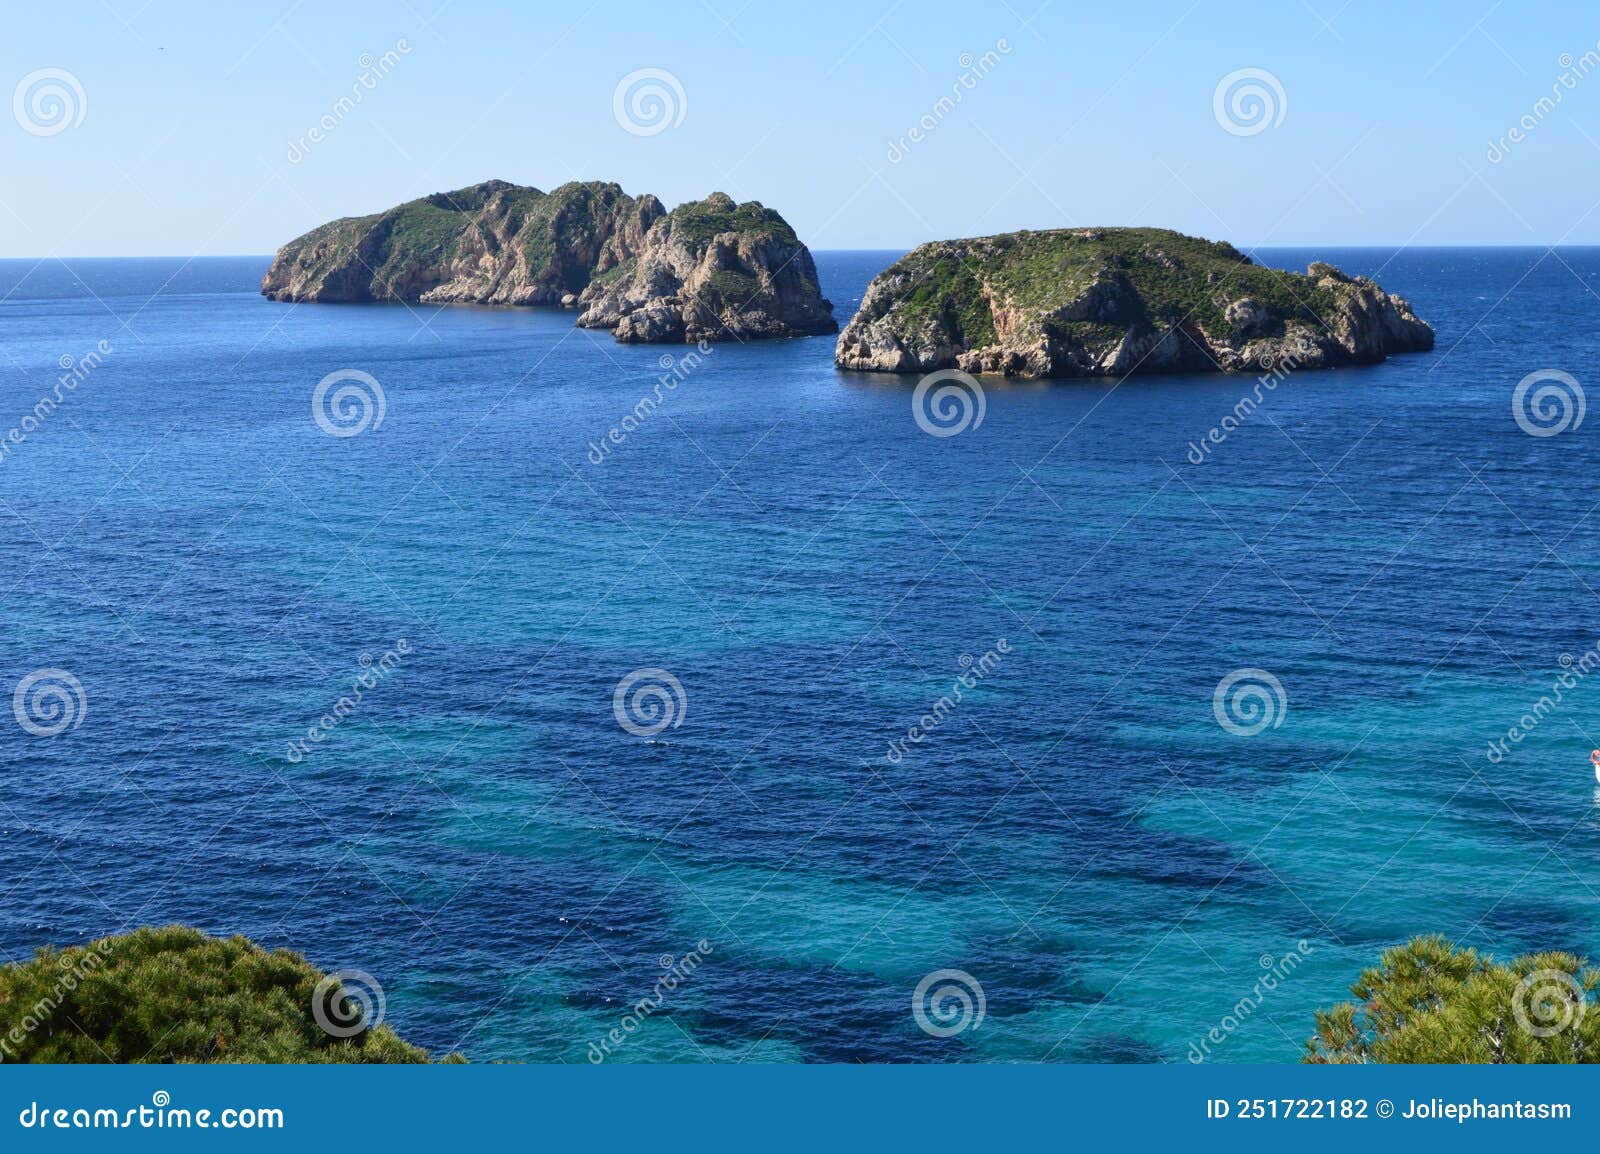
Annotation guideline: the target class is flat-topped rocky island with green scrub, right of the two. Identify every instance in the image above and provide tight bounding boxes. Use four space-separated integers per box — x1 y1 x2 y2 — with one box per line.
835 229 1434 378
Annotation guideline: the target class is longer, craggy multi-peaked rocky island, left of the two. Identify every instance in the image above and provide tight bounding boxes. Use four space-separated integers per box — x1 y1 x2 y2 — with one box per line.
261 181 838 343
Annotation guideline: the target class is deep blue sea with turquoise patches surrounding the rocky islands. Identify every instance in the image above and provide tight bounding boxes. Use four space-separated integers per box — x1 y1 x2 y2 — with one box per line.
0 250 1600 1061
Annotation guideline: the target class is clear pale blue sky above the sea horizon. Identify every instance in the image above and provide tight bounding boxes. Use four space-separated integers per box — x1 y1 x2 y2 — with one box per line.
0 0 1600 258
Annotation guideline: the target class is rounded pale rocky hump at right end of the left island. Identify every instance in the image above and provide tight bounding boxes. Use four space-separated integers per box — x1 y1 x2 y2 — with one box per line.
578 192 838 343
